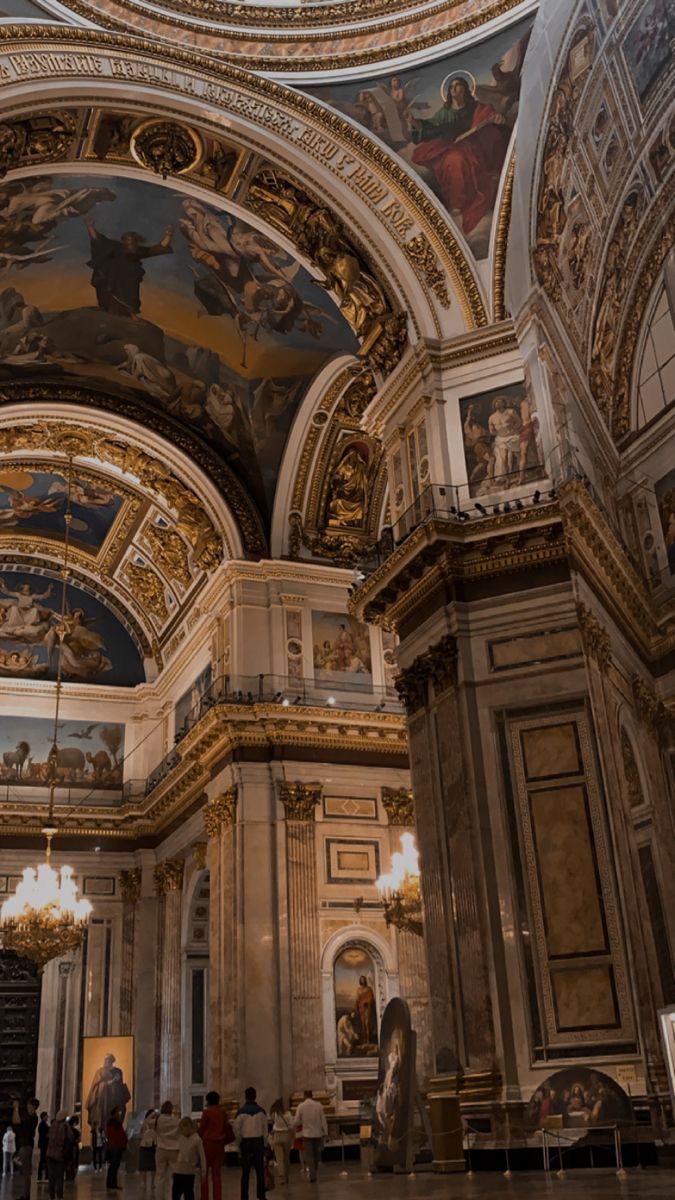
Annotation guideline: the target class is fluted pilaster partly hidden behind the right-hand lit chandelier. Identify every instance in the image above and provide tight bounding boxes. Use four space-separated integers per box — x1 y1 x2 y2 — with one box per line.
382 787 435 1082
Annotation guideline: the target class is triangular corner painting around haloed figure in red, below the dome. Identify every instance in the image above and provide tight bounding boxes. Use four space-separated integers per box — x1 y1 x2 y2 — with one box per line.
306 19 532 258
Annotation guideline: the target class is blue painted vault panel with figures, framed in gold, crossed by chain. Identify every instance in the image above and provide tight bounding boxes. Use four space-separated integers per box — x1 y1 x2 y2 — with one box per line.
0 467 123 553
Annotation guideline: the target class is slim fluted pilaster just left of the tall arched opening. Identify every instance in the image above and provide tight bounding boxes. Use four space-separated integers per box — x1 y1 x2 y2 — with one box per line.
154 858 185 1104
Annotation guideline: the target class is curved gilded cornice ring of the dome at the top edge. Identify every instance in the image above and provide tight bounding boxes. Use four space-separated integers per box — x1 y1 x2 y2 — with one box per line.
42 0 521 72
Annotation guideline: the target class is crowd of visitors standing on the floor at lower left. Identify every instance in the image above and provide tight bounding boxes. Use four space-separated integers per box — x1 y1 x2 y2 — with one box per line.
2 1087 328 1200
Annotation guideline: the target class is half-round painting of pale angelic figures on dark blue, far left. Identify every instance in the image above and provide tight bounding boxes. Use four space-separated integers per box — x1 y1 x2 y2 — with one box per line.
0 565 145 686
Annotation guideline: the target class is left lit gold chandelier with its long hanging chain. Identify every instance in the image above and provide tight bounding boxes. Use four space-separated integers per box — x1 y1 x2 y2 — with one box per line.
0 458 91 970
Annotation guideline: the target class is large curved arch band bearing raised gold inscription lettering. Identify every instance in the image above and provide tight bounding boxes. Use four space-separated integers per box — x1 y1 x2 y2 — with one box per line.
0 25 488 329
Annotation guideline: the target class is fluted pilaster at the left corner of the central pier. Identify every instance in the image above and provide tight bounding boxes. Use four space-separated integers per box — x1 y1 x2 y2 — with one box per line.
204 786 240 1096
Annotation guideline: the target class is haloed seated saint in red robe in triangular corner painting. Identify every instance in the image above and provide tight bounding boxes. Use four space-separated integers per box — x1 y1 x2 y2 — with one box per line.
412 74 510 235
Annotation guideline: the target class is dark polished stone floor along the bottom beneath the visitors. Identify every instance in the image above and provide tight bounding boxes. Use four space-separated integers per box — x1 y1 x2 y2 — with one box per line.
0 1163 675 1200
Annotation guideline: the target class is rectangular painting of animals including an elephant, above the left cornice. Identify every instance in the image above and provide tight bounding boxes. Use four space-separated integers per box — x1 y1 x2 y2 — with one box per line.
0 716 124 788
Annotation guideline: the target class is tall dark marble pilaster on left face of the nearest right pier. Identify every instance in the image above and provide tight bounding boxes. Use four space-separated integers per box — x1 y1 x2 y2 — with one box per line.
396 634 496 1073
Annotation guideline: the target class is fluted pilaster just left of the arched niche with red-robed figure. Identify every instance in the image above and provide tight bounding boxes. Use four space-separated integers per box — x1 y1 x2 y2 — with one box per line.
279 782 324 1088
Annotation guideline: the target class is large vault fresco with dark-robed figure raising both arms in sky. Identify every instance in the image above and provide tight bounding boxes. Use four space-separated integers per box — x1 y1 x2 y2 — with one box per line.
0 173 358 520
